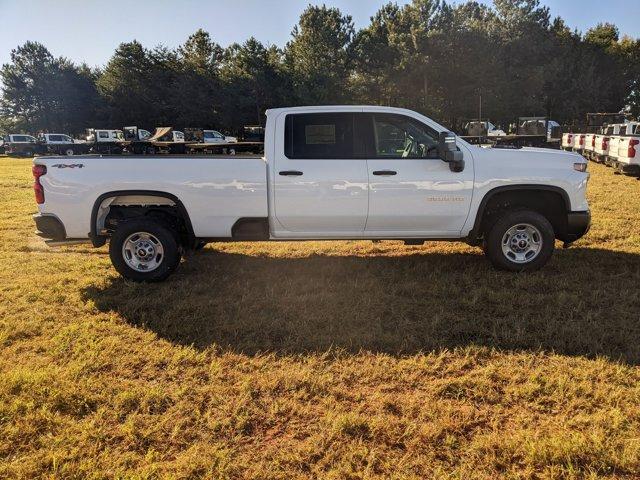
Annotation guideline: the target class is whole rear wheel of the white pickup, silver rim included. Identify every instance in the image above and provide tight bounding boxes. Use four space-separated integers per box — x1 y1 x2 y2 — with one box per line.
109 218 180 282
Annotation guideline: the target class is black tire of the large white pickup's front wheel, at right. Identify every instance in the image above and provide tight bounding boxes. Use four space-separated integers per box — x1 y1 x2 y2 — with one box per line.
483 210 555 272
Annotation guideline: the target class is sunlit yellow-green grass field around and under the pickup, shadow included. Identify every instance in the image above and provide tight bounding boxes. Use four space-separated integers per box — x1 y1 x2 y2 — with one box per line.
0 158 640 479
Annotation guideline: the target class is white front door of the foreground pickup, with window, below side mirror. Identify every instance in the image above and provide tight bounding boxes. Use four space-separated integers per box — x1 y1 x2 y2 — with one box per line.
362 113 474 238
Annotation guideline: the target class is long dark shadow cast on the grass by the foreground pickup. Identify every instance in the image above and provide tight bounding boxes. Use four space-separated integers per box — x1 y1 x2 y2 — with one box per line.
83 248 640 364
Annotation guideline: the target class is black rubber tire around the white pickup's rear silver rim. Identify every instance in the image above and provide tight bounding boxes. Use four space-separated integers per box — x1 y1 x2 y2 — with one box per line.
109 218 180 282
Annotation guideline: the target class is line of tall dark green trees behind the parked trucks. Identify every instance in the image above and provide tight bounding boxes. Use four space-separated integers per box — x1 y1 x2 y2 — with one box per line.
0 0 640 134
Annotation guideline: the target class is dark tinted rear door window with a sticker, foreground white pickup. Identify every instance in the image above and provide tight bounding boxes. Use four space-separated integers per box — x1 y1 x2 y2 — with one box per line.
284 112 364 159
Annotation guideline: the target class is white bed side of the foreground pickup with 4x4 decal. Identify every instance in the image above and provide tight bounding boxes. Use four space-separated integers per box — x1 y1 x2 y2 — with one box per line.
34 155 268 238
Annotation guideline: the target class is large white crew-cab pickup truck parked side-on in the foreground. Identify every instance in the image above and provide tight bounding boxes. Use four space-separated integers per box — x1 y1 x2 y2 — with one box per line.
33 106 591 281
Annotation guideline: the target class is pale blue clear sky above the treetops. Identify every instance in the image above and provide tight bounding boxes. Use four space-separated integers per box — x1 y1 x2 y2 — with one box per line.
0 0 640 66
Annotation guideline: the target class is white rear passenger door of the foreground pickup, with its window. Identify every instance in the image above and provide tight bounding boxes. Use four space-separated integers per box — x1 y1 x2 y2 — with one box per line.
272 112 368 234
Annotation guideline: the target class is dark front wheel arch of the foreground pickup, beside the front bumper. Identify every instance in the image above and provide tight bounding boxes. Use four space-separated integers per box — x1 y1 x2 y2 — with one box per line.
469 184 571 245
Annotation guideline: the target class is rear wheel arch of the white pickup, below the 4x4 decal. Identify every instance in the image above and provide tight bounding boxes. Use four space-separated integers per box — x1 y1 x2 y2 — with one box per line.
89 190 196 248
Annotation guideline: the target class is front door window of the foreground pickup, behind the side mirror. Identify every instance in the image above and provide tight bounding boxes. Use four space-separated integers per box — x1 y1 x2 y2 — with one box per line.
373 114 438 158
